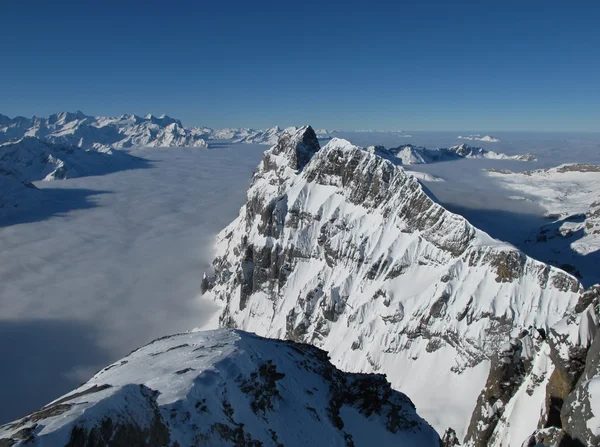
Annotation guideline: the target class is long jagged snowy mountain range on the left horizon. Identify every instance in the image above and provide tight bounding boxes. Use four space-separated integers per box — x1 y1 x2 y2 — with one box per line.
0 112 207 150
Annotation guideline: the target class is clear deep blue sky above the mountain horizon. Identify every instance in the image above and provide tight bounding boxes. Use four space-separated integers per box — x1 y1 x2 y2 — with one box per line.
0 0 600 131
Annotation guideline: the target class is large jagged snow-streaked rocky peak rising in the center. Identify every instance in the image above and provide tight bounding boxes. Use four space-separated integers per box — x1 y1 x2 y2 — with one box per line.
203 127 598 446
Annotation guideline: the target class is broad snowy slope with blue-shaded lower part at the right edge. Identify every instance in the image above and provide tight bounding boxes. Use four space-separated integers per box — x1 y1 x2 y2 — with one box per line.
488 164 600 283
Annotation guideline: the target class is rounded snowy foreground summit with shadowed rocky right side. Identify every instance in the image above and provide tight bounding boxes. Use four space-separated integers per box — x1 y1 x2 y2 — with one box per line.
0 330 439 447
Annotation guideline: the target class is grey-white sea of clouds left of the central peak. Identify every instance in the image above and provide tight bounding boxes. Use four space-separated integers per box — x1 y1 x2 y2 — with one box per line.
0 143 265 423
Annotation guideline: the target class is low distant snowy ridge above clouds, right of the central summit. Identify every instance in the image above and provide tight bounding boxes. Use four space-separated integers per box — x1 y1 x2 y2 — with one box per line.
388 144 536 165
